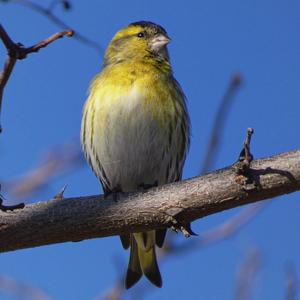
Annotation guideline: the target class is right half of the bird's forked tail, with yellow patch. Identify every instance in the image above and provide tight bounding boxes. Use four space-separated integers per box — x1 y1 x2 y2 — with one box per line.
138 246 162 287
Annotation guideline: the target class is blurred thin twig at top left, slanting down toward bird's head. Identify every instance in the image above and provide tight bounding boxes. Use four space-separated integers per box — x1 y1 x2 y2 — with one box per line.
2 0 103 54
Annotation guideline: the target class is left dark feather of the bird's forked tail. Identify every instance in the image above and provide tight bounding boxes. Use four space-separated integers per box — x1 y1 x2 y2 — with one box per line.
125 235 143 289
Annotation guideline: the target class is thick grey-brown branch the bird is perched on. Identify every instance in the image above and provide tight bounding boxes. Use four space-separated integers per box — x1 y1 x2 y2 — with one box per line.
0 149 300 252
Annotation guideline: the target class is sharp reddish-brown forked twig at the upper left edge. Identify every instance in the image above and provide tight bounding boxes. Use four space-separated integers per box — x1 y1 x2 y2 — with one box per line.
0 24 73 132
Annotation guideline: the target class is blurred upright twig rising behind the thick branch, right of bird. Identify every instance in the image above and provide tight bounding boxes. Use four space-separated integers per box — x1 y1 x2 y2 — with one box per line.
200 74 242 174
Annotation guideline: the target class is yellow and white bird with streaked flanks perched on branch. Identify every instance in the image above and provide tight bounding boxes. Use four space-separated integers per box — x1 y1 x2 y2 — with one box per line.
80 21 190 289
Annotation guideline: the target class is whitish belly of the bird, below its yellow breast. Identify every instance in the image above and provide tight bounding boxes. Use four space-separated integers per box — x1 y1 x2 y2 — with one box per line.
91 86 176 192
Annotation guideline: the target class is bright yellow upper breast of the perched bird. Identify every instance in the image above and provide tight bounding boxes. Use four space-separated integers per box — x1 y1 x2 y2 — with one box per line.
89 63 180 126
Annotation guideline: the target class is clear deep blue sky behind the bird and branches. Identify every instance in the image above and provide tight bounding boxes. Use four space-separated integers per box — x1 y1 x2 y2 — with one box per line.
0 0 300 300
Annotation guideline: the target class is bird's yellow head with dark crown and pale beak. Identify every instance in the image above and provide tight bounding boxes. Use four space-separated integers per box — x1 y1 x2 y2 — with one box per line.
104 21 170 65
